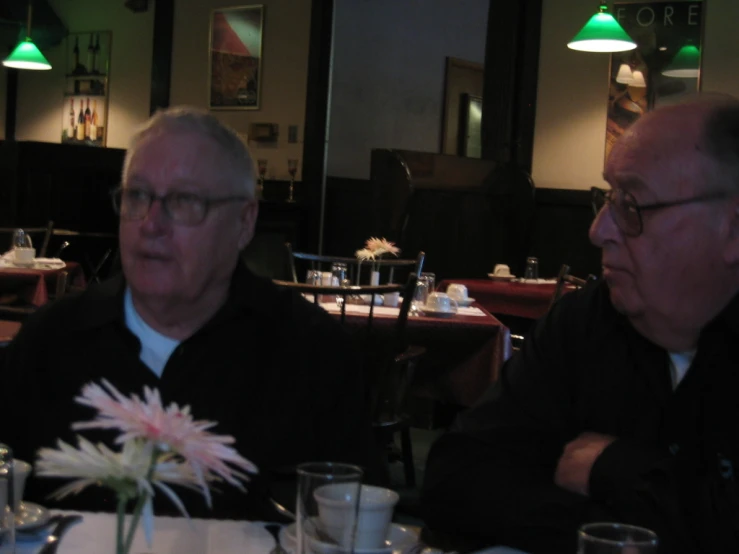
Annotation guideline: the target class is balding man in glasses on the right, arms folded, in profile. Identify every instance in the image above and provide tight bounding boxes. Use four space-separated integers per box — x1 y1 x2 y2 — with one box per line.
422 98 739 554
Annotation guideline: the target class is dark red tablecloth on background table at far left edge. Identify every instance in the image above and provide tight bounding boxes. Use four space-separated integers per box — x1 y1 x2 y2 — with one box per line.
0 262 85 306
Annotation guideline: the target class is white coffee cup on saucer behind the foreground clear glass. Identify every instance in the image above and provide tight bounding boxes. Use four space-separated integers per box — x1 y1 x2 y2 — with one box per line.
313 483 399 550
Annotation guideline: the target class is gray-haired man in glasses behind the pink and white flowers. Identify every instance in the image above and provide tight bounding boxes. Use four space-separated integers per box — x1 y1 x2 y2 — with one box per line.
2 108 379 520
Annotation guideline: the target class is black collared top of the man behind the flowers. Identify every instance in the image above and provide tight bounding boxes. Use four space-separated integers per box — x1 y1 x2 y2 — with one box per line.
0 266 377 519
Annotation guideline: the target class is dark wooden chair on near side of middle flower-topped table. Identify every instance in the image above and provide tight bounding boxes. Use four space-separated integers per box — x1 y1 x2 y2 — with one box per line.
273 273 425 486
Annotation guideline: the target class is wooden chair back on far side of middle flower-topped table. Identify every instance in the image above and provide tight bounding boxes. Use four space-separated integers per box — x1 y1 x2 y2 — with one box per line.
285 243 426 285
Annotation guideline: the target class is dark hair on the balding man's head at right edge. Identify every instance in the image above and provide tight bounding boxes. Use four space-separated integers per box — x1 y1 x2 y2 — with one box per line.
703 98 739 193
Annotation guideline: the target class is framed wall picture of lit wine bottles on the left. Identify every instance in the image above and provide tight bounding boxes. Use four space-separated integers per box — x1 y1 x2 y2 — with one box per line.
61 31 111 146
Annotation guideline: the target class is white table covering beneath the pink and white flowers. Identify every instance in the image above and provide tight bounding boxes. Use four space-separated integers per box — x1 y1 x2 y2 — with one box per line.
16 512 275 554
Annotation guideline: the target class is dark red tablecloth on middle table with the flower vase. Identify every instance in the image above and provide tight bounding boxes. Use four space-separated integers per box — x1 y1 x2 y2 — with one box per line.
332 302 511 406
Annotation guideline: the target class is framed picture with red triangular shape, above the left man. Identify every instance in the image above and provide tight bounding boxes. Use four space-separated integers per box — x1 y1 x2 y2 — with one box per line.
208 5 264 110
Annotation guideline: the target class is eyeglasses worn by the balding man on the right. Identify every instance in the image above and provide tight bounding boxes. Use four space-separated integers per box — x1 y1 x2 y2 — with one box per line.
590 187 730 237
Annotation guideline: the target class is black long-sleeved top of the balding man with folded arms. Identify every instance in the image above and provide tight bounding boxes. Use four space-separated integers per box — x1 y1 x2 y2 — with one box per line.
423 284 739 554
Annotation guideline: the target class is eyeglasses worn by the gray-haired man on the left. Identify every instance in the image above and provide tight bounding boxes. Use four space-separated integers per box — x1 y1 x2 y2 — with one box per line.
112 187 249 226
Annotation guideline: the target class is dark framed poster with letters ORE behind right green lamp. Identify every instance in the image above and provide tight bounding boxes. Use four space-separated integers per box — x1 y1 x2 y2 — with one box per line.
605 0 706 162
